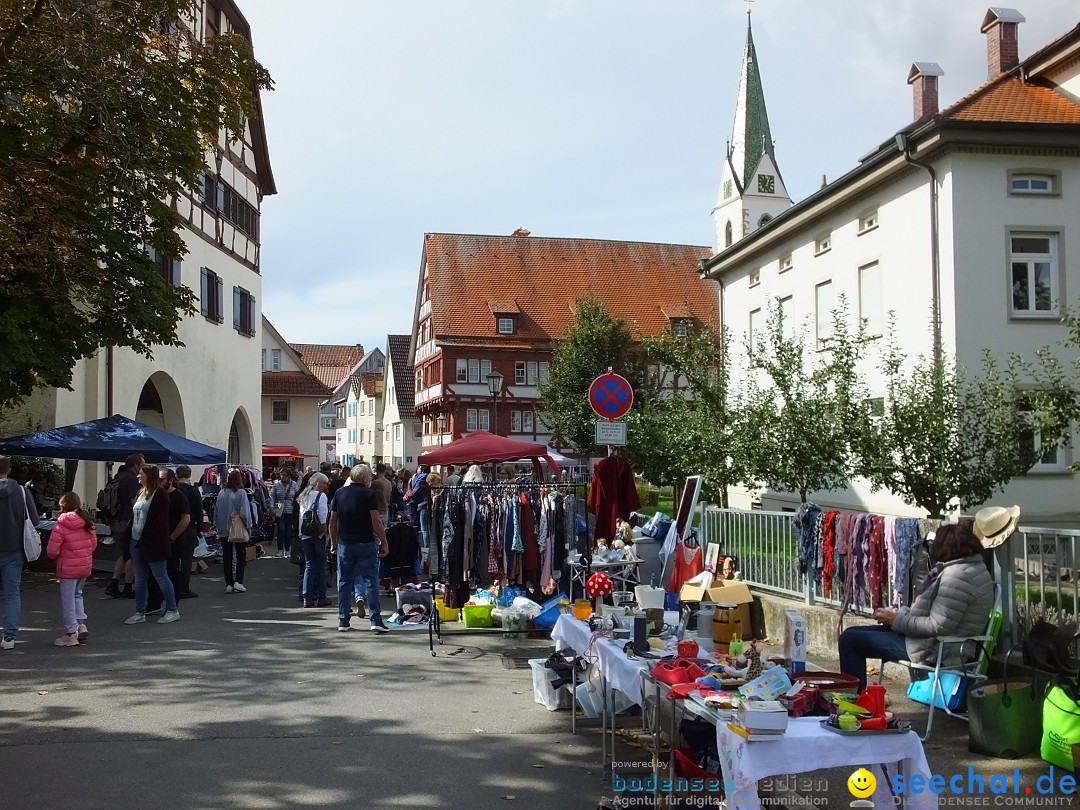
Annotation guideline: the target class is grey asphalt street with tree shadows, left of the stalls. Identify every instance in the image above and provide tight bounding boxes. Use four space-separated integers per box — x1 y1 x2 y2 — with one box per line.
0 558 603 810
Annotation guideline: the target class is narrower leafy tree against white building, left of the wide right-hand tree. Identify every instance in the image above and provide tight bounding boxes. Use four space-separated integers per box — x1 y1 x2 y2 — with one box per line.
740 296 868 503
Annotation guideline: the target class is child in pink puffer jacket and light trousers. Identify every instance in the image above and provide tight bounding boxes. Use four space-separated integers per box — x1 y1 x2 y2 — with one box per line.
48 492 97 647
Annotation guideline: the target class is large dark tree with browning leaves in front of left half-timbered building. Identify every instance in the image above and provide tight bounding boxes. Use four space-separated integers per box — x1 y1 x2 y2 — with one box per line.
0 0 271 405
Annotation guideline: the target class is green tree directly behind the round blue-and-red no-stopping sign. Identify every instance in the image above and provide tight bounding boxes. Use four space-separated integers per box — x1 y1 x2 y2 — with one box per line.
538 296 644 459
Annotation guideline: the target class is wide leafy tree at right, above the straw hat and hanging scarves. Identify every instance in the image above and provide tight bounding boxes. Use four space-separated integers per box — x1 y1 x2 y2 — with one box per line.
856 330 1077 517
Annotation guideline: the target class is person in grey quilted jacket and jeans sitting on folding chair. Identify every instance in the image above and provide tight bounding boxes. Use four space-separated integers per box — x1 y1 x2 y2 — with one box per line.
838 524 994 690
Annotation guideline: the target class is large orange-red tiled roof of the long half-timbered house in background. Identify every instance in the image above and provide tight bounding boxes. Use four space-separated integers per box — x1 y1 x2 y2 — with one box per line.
424 233 719 341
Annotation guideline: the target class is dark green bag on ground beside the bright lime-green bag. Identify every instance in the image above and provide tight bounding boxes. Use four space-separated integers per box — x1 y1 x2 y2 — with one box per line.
968 645 1045 759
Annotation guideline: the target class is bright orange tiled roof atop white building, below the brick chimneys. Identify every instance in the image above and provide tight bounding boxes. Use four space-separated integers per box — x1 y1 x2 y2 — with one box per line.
939 73 1080 124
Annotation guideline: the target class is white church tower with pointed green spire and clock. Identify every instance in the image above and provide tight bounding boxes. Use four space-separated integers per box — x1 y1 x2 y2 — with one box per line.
713 11 792 253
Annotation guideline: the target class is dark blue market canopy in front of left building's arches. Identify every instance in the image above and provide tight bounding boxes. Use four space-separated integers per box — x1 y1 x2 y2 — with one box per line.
0 414 225 465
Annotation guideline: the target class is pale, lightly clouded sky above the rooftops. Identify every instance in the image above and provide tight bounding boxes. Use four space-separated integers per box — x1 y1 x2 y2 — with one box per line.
240 0 1080 349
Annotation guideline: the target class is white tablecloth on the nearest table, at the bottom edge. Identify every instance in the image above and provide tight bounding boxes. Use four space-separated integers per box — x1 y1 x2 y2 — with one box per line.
716 717 937 810
